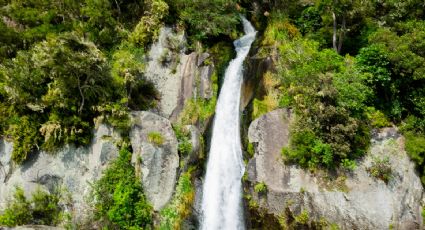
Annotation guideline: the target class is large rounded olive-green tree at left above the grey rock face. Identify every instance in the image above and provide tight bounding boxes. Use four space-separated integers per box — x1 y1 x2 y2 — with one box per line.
0 33 113 160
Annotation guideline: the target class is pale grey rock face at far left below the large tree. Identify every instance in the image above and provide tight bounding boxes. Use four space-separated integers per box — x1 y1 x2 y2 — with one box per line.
0 125 120 222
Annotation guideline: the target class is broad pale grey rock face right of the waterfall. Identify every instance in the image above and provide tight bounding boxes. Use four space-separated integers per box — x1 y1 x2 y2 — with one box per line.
247 110 423 230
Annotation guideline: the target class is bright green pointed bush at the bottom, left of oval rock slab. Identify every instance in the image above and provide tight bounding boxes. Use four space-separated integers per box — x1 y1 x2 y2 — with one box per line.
91 148 153 229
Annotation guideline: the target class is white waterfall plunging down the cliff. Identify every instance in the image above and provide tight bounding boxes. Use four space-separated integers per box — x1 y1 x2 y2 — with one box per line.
201 18 256 230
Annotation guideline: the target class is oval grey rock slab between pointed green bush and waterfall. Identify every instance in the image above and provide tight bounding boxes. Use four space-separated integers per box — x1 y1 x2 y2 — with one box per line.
130 112 179 211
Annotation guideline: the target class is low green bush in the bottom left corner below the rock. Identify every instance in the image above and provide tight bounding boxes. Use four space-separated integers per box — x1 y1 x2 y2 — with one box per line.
0 187 63 227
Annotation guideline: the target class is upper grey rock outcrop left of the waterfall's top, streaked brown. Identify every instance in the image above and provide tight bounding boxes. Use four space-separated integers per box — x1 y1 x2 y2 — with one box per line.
145 27 213 121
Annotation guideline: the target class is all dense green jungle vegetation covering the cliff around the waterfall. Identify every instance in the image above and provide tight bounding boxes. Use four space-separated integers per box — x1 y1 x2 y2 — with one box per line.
0 0 425 229
